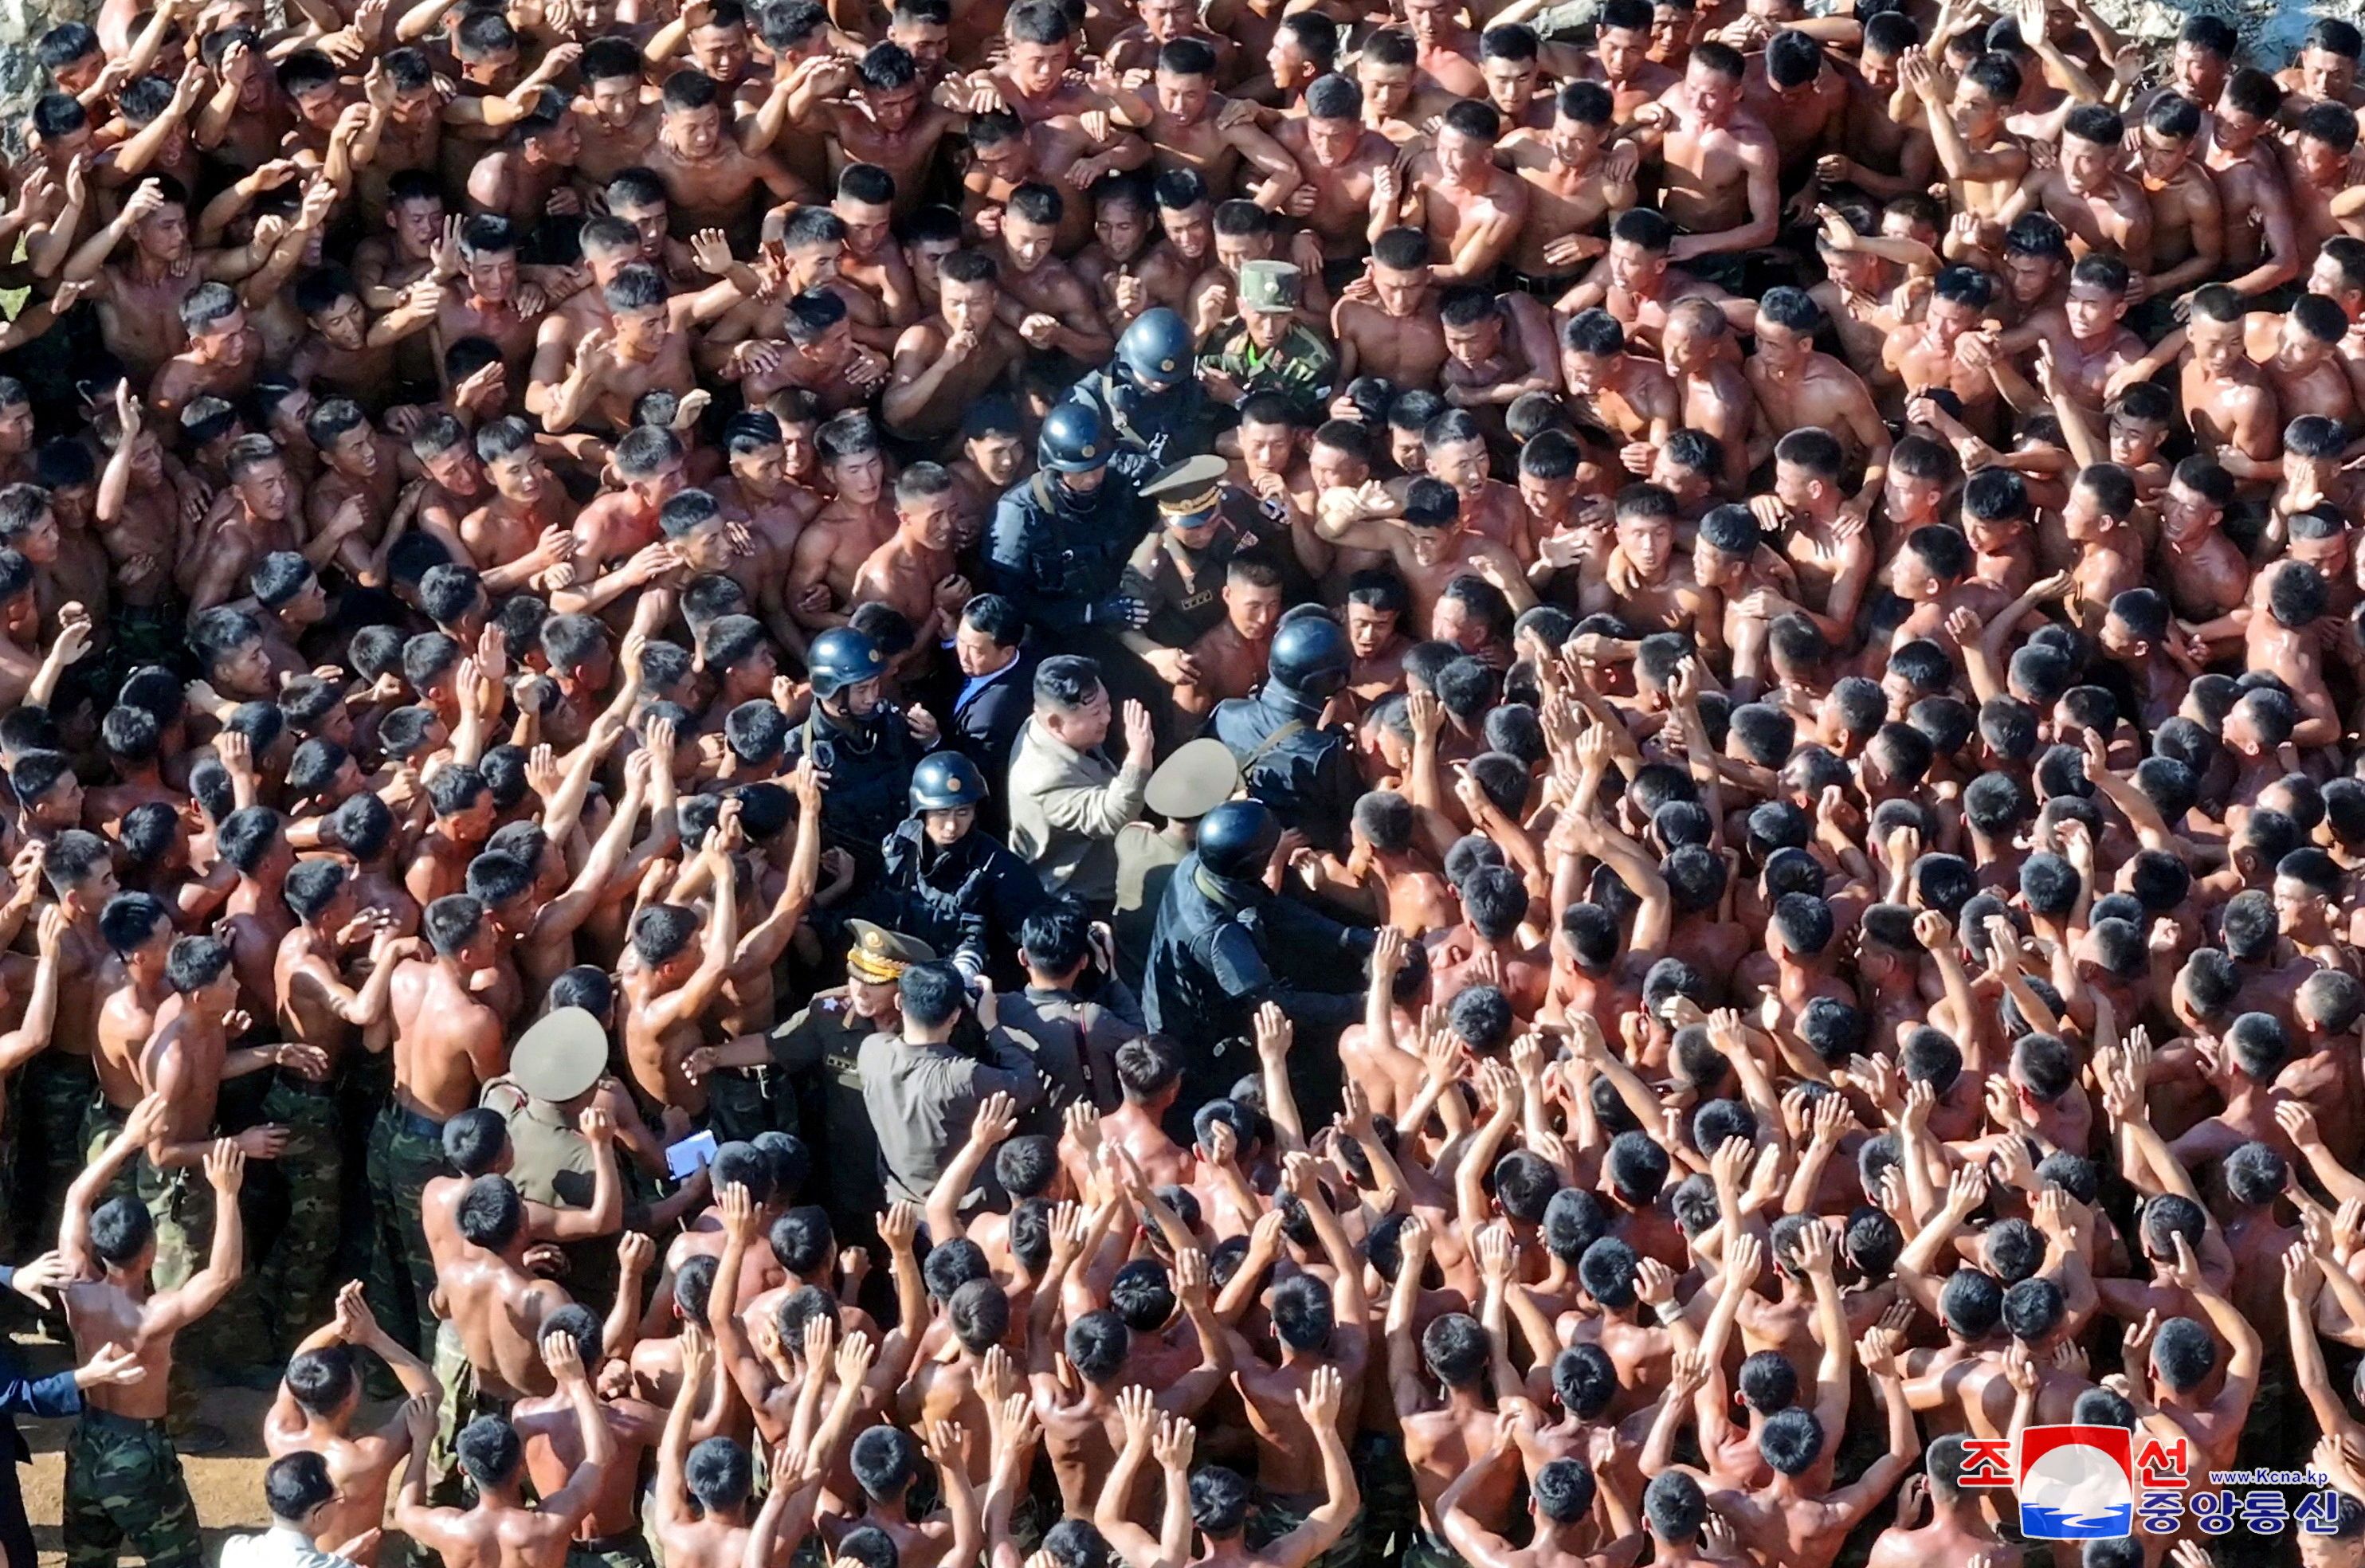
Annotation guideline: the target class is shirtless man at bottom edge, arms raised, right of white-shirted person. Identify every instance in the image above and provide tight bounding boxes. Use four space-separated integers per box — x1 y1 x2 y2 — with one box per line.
395 1324 615 1568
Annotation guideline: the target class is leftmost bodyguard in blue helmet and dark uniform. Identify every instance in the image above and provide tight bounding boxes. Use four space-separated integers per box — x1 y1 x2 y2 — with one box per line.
787 627 936 875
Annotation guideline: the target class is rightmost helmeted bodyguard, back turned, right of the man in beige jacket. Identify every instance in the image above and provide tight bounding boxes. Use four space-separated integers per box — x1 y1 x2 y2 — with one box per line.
1206 606 1363 854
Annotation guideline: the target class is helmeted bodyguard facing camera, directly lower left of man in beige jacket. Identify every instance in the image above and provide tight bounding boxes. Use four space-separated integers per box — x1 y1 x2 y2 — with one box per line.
873 752 1048 991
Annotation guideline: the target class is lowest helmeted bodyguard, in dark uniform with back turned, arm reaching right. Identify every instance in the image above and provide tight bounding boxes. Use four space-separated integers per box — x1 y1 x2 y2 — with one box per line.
1143 799 1371 1119
